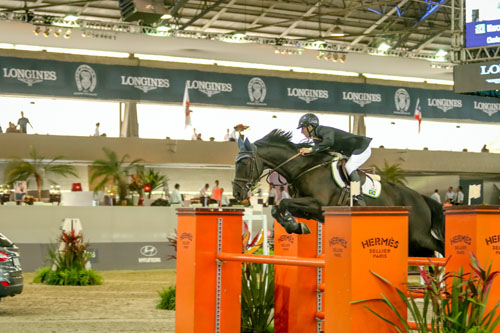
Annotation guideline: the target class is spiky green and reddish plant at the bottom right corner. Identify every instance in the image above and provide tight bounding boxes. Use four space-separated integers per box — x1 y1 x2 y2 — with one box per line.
352 254 500 333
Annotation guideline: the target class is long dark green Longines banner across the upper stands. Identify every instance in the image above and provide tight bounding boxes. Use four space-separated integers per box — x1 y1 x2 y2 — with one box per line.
0 57 500 122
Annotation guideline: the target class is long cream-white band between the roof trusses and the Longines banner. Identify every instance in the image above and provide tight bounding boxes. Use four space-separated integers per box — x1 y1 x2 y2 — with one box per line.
0 21 453 80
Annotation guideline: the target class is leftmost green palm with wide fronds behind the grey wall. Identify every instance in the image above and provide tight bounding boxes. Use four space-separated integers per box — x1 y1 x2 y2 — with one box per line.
5 147 78 201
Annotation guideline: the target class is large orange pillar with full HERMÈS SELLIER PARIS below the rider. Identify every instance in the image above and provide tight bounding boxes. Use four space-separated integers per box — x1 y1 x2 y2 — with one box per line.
323 207 409 333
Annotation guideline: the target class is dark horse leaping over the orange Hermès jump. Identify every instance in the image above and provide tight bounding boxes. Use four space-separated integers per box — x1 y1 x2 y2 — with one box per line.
233 130 444 257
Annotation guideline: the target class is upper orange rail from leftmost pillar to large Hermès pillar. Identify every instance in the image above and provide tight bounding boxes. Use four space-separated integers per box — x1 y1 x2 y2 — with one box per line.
217 253 325 267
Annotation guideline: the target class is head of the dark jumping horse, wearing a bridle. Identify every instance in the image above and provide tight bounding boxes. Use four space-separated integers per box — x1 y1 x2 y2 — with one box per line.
233 139 264 200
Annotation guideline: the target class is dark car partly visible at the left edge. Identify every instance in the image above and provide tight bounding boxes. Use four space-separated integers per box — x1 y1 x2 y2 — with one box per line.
0 234 24 300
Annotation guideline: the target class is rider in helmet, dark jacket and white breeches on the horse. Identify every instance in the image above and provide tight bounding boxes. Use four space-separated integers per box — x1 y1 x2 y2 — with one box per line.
297 113 372 206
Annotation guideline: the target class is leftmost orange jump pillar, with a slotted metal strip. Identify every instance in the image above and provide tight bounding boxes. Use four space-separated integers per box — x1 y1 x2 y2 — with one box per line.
175 208 244 333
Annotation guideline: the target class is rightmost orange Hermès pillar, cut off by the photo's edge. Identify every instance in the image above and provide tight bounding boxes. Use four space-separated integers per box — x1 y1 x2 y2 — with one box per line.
445 205 500 333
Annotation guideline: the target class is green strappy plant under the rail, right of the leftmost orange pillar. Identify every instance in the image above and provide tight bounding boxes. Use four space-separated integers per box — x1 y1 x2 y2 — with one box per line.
241 263 274 332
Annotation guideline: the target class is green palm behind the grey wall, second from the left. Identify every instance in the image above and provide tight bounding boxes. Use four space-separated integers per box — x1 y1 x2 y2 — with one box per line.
90 147 142 204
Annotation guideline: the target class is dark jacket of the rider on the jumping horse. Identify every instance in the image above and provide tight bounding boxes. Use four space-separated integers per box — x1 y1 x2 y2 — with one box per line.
313 125 372 156
